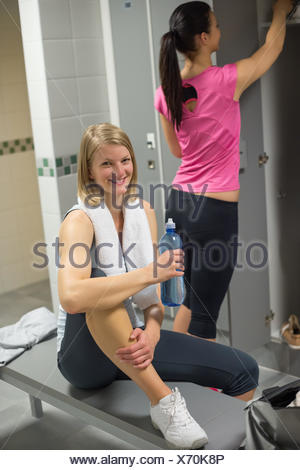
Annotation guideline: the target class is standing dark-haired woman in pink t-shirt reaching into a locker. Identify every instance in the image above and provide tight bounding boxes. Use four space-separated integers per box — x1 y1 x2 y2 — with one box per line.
155 0 293 340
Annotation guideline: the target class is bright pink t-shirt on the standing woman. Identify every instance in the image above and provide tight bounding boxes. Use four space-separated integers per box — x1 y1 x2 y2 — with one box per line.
155 64 241 193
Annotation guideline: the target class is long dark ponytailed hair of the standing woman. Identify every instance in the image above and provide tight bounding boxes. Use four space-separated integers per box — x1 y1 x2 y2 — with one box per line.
159 2 210 130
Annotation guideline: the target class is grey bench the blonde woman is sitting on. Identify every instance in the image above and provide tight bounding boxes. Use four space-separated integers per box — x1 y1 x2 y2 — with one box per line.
0 338 246 450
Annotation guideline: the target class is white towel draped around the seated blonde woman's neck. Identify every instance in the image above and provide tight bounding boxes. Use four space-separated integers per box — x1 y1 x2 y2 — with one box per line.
78 198 159 310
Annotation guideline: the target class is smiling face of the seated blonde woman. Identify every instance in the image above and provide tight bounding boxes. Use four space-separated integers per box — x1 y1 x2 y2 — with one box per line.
89 145 133 198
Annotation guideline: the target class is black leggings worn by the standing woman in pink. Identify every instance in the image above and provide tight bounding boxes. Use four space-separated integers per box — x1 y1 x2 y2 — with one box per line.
166 189 238 338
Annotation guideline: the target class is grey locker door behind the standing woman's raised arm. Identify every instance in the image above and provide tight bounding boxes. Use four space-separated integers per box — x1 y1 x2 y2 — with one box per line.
214 0 270 351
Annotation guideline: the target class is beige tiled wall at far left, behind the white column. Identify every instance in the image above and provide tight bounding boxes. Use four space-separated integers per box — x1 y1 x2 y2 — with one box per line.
0 0 48 294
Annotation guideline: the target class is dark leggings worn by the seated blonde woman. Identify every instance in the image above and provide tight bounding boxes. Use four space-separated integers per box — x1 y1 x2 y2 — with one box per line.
58 269 258 396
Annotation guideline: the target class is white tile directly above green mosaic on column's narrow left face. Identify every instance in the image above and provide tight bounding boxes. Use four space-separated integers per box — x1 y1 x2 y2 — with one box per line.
32 119 54 159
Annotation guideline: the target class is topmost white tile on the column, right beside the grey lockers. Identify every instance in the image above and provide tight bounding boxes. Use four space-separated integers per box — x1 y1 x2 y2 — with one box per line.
70 0 102 38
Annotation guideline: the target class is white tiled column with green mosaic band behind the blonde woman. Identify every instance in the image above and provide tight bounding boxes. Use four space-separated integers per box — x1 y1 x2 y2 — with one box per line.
19 0 109 311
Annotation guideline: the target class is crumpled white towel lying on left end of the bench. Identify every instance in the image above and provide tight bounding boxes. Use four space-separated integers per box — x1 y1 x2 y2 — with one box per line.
0 307 56 367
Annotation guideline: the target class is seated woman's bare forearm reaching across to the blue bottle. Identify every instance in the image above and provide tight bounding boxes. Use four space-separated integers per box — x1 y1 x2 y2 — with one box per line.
59 266 153 313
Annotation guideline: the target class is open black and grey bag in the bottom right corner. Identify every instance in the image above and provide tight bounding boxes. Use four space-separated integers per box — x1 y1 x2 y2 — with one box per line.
245 380 300 450
